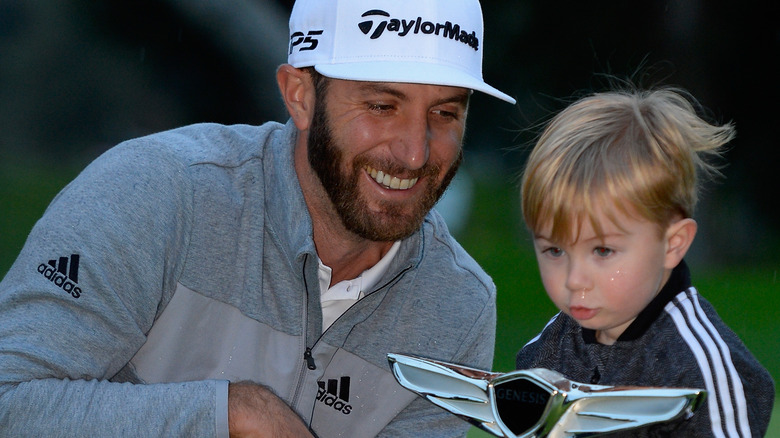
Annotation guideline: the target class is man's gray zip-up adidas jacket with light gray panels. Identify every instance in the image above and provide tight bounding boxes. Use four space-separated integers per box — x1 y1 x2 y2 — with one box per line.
0 122 496 438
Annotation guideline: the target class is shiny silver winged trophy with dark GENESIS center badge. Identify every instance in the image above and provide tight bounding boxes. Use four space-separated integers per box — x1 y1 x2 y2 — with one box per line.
387 353 706 438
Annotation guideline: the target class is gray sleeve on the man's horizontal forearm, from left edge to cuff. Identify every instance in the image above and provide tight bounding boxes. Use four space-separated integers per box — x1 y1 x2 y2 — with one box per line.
0 379 222 437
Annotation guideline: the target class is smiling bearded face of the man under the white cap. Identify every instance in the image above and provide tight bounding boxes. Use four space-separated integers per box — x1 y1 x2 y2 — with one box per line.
308 79 469 241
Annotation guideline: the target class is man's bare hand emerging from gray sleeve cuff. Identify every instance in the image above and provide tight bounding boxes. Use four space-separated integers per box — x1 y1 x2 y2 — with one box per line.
228 382 312 438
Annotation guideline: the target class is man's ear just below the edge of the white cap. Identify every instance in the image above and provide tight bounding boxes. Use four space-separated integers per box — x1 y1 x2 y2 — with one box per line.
276 64 315 131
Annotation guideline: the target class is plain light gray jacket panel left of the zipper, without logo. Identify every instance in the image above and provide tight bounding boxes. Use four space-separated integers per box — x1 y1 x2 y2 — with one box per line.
131 285 303 397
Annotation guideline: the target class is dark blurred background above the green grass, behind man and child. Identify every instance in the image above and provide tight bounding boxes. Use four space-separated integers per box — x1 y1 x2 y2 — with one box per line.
0 0 780 263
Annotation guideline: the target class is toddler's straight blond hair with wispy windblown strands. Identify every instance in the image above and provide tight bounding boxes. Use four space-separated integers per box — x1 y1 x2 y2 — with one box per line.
521 88 735 242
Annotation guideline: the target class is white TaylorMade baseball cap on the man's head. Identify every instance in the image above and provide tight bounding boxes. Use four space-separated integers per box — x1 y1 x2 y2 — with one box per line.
287 0 515 104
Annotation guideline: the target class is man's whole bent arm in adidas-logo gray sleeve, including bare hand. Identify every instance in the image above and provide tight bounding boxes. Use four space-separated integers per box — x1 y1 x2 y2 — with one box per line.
0 137 316 437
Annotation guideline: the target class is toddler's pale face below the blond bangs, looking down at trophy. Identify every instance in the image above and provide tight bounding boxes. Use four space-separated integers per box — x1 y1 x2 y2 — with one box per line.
534 206 673 344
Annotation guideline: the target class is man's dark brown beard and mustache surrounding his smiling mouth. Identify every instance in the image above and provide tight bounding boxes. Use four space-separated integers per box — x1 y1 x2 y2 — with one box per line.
308 96 463 242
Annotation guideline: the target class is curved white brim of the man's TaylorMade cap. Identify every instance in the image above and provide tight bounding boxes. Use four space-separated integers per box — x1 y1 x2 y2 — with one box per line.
314 61 516 104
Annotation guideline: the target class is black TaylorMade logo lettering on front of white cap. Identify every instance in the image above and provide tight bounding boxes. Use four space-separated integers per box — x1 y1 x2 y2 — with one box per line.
358 9 479 50
